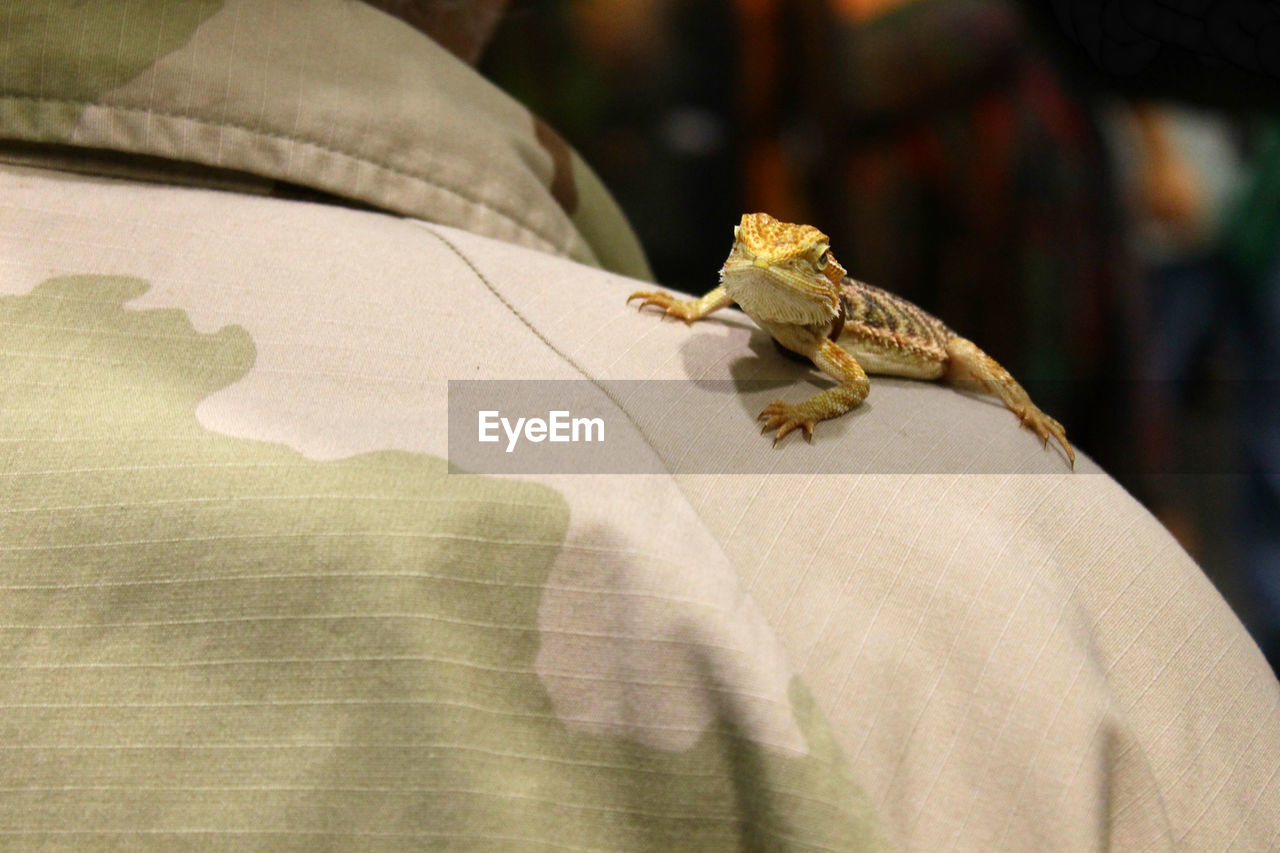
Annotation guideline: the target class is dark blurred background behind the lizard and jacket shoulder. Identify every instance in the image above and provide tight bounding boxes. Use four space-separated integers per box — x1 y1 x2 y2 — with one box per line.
481 0 1280 667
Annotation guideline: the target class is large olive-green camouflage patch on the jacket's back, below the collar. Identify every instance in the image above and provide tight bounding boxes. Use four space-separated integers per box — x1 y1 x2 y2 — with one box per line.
0 275 879 850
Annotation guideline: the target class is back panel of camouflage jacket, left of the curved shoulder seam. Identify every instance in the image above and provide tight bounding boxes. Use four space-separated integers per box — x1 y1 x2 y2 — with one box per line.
0 162 883 850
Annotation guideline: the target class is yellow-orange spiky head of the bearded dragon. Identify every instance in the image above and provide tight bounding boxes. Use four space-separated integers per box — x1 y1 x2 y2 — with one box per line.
721 214 845 325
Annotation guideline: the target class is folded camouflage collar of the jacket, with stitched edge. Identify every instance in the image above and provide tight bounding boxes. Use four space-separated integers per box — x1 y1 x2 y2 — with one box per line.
0 0 648 277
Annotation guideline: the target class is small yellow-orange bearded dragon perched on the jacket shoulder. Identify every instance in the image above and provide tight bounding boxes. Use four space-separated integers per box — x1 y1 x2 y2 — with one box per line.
627 213 1075 469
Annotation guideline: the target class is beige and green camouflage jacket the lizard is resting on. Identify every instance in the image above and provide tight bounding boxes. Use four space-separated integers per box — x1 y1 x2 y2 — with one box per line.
0 0 1280 850
